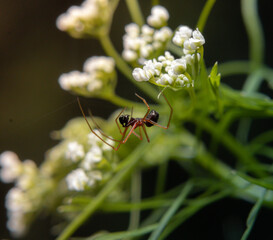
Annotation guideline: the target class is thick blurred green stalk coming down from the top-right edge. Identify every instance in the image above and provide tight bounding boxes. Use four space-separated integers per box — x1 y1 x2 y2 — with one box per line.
241 0 265 69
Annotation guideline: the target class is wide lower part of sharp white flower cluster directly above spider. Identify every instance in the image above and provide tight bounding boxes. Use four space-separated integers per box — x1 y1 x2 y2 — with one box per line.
133 52 199 88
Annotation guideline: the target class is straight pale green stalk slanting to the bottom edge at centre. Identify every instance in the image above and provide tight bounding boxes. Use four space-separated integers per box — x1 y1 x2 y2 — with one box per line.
149 181 193 240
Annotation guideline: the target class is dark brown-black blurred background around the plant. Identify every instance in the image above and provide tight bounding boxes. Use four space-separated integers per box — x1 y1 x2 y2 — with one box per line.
0 0 273 239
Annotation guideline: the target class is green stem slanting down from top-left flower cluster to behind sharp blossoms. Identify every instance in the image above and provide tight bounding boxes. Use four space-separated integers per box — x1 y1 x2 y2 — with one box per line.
99 35 158 102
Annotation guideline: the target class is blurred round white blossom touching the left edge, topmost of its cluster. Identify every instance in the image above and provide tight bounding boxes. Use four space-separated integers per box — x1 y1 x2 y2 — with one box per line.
0 151 23 183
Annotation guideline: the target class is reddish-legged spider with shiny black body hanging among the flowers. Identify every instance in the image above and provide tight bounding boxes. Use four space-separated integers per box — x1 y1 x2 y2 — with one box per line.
77 93 173 151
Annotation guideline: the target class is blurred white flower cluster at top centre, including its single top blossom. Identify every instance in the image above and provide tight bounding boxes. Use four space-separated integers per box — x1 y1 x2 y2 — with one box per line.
122 6 172 64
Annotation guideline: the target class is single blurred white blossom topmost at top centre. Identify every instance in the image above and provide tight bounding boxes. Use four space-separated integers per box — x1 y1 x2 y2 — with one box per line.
147 5 169 28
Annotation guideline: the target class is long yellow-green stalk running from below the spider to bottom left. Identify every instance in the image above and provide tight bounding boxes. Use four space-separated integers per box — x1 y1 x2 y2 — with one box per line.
57 131 159 240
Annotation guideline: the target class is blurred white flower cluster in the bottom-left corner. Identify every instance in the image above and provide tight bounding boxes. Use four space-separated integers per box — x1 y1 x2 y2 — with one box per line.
0 151 39 236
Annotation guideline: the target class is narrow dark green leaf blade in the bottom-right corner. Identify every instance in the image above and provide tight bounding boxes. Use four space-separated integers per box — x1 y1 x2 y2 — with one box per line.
241 190 266 240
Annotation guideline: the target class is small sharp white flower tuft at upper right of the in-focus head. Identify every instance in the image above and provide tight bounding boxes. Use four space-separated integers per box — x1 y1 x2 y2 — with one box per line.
173 26 205 54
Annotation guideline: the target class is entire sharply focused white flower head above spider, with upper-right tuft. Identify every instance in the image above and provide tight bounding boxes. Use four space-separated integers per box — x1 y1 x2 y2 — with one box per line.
133 26 205 90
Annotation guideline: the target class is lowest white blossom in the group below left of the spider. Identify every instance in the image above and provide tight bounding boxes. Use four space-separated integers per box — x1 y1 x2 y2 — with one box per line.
65 168 89 191
